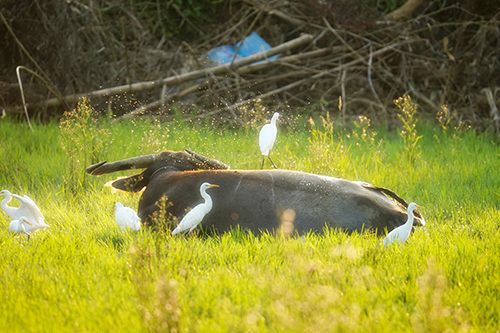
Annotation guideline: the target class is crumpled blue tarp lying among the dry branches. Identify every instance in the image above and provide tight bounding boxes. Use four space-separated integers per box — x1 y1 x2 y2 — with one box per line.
208 32 280 65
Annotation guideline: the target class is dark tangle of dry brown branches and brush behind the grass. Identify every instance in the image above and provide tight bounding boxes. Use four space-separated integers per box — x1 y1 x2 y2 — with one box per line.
0 0 500 130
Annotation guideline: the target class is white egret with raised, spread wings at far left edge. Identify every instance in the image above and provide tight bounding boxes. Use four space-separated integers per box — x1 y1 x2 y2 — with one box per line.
0 190 49 233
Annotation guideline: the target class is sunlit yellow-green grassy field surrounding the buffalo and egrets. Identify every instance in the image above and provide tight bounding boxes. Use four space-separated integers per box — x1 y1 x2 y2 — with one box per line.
0 100 500 332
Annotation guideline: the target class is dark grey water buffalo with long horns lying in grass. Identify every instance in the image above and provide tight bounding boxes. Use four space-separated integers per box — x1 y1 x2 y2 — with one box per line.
86 150 425 235
